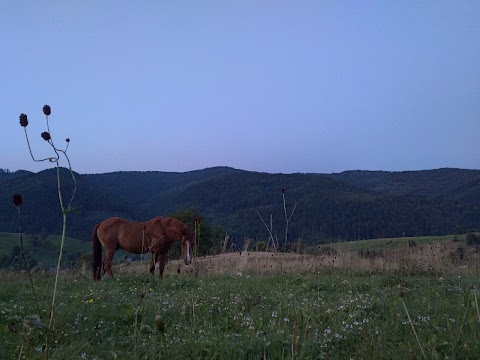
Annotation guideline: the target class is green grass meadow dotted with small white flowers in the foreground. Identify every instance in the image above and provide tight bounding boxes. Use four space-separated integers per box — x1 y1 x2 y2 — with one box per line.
0 272 480 360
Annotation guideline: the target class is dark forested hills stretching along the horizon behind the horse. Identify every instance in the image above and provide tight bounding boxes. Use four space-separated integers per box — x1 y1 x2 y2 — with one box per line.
0 167 480 242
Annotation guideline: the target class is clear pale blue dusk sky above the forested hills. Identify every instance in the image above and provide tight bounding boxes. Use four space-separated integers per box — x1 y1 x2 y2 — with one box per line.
0 0 480 173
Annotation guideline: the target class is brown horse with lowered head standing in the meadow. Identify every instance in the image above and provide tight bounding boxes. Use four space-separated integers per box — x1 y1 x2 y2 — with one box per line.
92 216 195 280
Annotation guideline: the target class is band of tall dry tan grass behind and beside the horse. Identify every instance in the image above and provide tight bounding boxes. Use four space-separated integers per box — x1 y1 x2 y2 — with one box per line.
117 241 480 276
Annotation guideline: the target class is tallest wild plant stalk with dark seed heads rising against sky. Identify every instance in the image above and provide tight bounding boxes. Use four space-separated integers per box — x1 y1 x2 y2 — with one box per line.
20 105 77 332
